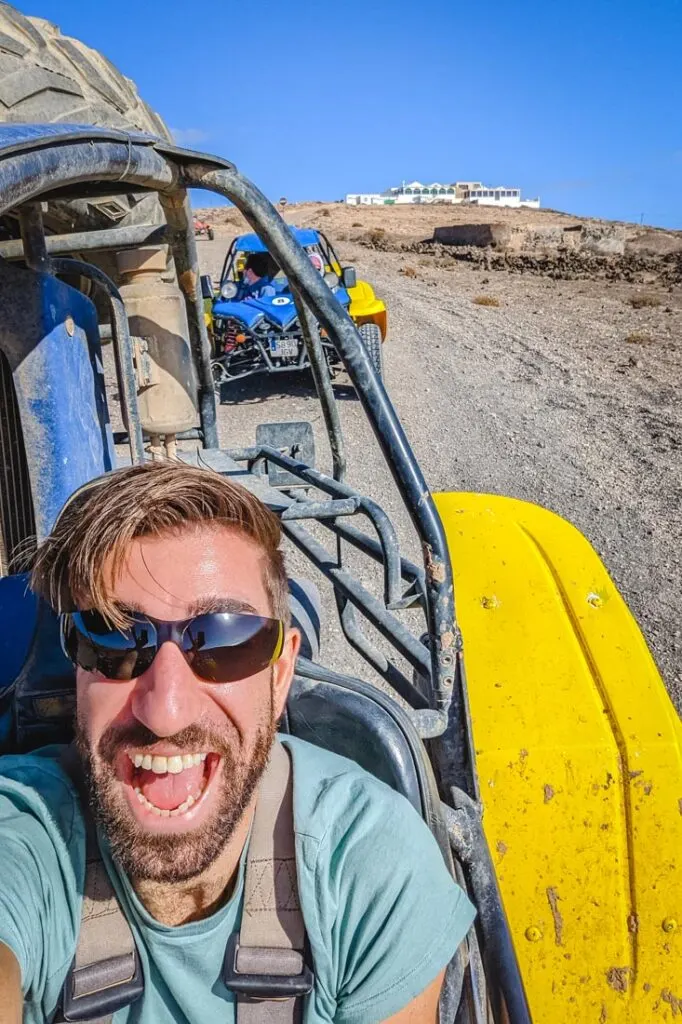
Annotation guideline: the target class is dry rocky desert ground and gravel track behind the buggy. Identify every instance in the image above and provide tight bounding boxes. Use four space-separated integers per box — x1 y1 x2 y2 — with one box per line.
192 203 682 709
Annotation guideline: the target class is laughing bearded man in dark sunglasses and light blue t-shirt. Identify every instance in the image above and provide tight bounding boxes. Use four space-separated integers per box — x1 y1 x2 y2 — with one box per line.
0 463 473 1024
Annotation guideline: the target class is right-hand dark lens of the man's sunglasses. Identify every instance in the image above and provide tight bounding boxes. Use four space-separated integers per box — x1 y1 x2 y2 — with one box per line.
182 612 283 683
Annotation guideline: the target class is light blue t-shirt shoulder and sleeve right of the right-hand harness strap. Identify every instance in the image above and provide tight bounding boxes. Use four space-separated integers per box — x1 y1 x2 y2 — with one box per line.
284 737 473 1024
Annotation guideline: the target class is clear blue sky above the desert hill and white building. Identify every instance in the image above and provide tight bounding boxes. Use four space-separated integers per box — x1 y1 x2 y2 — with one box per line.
30 0 682 228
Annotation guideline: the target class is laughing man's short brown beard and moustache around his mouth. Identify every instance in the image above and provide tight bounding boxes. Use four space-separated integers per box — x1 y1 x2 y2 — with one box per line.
76 694 276 884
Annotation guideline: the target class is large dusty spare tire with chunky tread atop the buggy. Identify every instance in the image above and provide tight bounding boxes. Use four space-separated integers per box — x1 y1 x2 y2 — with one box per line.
0 3 171 231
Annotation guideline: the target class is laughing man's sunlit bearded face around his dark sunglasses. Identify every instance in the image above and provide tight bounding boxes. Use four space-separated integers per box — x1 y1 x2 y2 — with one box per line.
77 526 299 882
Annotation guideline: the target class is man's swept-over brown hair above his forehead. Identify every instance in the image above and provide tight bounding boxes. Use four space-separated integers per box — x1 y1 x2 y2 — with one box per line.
31 462 290 627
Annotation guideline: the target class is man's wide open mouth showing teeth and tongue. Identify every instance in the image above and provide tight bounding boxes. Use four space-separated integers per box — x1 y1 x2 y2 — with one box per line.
126 750 221 818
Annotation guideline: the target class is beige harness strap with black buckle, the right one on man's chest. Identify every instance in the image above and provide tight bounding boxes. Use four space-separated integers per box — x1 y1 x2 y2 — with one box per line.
223 740 314 1024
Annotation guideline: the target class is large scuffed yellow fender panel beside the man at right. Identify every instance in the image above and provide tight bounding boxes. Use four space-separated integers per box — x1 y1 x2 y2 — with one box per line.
434 494 682 1024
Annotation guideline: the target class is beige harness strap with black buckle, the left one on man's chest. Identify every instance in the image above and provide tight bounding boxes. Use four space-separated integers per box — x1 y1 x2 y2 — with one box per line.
57 744 143 1024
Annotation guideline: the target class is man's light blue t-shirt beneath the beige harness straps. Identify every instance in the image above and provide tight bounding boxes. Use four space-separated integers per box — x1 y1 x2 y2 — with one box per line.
0 737 474 1024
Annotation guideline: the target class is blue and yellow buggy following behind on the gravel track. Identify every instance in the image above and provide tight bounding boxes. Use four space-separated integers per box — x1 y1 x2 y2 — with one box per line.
212 227 386 387
